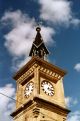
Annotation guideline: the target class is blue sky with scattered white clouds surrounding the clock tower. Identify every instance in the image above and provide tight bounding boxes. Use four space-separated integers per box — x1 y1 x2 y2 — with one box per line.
0 0 80 121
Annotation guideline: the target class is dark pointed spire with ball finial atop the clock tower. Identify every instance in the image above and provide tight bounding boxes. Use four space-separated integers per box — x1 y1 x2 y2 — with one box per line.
29 26 49 59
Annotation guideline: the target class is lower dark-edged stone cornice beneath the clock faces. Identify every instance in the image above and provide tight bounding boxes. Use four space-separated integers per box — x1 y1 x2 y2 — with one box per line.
11 97 70 117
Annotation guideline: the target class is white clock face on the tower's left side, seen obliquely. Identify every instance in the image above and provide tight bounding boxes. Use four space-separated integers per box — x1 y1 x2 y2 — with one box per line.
24 82 34 97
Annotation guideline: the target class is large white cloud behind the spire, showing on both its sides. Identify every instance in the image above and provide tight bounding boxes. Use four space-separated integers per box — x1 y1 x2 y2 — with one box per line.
1 10 55 70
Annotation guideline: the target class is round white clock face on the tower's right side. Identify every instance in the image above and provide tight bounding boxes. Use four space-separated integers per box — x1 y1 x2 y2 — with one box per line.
41 80 54 96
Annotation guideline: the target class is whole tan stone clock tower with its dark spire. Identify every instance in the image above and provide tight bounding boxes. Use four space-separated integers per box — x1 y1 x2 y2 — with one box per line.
11 27 70 121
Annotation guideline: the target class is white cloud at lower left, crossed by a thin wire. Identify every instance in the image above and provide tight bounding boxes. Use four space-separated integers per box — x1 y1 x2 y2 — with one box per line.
0 84 15 121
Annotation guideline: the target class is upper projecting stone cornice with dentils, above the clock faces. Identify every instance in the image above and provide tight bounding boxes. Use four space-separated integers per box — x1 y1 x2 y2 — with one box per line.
13 57 66 80
